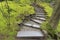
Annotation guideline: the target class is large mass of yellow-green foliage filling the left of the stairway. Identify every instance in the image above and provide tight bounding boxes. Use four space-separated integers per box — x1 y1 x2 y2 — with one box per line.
0 1 34 40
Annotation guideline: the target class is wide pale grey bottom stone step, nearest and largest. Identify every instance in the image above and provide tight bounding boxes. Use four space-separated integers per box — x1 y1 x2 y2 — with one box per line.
17 31 44 38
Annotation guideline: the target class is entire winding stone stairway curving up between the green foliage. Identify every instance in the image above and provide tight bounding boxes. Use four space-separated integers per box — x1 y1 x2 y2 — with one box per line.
17 6 46 40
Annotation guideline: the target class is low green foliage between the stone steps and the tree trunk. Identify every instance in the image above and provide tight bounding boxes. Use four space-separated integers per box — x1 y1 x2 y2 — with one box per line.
41 21 56 34
